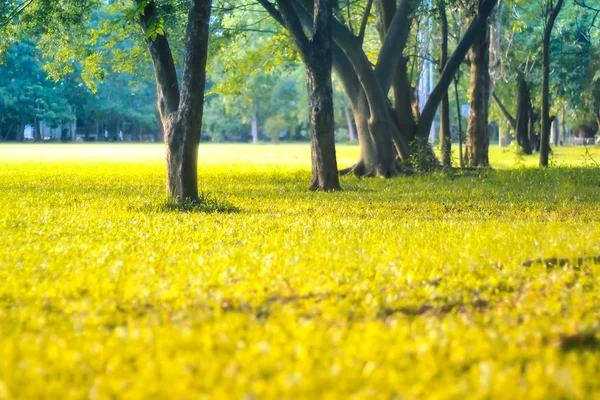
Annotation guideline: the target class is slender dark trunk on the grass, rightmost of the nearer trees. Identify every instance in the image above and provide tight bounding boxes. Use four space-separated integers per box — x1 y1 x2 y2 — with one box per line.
540 0 564 167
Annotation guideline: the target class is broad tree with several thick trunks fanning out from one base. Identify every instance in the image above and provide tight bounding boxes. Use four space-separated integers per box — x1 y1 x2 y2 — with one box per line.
260 0 496 177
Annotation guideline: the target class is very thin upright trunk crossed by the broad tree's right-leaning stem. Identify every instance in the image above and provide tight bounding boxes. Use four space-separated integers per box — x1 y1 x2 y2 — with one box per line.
438 0 452 167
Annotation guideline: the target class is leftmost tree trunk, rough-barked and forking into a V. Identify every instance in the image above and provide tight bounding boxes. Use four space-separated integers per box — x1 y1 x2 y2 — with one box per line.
137 0 211 202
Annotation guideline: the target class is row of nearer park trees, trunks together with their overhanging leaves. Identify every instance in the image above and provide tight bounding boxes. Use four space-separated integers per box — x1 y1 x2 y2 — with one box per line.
5 0 600 199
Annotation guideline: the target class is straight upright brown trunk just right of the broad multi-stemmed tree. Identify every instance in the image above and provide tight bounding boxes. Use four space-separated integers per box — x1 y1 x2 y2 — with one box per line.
466 0 490 167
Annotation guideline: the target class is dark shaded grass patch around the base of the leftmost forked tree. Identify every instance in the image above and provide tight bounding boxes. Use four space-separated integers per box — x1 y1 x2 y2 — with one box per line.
127 193 242 214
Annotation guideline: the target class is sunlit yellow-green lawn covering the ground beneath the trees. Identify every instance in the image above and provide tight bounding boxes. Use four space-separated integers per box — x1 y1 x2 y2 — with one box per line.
0 145 600 399
